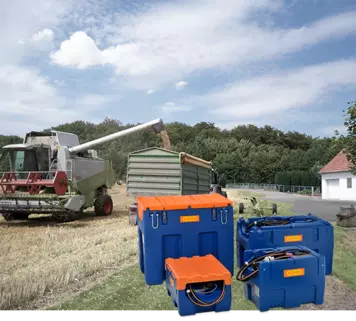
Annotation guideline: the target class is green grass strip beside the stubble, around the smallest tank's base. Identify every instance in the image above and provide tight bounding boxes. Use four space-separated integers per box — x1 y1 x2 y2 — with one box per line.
46 265 264 312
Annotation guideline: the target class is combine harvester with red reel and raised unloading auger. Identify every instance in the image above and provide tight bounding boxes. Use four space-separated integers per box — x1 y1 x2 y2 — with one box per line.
0 119 168 222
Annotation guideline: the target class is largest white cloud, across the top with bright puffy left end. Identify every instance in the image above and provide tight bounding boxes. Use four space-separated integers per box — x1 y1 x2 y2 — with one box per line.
51 0 356 90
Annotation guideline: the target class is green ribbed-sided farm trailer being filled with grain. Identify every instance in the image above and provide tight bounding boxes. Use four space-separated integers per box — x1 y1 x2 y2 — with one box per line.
126 147 214 224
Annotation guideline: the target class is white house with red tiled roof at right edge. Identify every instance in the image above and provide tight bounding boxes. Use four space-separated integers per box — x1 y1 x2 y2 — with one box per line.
319 151 356 201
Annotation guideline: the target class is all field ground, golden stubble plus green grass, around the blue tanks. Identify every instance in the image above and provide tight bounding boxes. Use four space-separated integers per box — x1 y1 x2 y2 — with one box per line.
0 188 356 312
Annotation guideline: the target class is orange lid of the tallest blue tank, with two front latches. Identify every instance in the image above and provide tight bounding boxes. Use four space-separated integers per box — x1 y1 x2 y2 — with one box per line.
137 193 232 220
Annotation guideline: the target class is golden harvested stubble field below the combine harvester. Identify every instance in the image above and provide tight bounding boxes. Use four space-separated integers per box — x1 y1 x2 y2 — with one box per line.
0 186 137 311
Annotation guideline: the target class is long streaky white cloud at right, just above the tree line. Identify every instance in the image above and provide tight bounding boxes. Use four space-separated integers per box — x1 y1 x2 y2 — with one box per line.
203 60 356 120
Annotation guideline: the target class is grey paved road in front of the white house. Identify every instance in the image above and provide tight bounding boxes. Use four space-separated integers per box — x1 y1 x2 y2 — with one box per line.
250 191 356 222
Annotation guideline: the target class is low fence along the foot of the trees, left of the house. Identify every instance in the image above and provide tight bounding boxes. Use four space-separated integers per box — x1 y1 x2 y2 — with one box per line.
226 183 321 196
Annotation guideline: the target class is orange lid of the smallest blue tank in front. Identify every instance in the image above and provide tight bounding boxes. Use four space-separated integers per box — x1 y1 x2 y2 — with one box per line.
166 254 232 290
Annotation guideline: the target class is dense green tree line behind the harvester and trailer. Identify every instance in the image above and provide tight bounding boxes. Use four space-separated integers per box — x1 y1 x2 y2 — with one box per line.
0 118 342 186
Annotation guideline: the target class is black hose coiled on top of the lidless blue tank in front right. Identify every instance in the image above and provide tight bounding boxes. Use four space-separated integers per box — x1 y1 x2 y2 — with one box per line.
236 249 311 282
